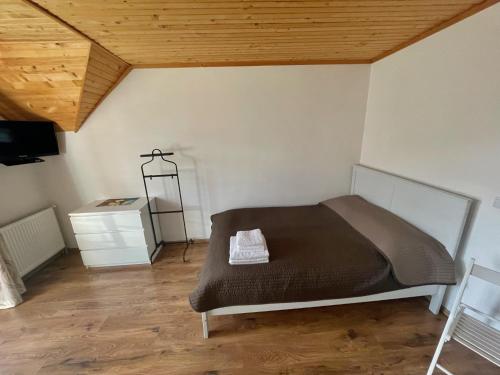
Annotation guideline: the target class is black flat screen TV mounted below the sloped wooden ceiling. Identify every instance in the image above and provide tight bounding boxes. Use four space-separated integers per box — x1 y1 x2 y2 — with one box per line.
0 121 59 165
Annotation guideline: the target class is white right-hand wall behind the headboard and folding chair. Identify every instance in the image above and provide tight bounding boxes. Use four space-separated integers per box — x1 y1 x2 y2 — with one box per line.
361 5 500 313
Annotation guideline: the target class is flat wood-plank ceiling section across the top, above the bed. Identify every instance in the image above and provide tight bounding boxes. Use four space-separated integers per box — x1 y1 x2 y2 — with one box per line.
34 0 492 66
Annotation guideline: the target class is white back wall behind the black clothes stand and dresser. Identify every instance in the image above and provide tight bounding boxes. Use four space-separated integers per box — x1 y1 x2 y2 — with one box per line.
46 65 369 246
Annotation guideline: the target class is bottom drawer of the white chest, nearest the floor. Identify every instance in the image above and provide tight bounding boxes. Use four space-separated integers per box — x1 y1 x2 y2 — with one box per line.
80 247 151 267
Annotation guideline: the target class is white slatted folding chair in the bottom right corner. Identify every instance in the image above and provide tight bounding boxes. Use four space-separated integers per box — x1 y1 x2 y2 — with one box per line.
427 259 500 375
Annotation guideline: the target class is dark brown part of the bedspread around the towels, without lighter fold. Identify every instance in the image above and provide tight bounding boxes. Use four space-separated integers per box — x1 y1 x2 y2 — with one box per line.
189 204 404 312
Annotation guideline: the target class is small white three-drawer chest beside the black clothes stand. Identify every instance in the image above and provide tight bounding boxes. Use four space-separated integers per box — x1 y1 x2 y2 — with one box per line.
69 198 161 267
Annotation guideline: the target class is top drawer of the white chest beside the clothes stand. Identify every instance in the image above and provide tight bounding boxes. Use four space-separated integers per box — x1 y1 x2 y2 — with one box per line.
71 213 142 234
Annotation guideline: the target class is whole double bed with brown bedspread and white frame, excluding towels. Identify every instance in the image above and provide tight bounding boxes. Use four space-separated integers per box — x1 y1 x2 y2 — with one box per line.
190 165 472 338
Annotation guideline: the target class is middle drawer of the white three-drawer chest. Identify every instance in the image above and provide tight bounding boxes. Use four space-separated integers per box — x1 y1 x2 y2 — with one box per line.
75 230 147 250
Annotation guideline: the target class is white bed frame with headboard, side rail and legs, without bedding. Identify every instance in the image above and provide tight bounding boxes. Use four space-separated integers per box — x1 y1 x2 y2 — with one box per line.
201 165 473 338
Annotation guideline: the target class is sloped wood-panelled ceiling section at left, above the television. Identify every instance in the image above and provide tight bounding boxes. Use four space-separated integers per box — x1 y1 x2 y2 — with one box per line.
0 0 128 131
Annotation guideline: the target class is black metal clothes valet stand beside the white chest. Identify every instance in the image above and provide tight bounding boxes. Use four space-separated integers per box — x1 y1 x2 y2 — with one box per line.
140 148 193 262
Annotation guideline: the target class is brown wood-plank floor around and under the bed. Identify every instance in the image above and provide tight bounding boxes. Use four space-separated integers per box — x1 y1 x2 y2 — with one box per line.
0 245 498 375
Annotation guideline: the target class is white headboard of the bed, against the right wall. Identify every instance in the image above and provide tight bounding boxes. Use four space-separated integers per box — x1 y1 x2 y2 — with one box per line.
351 165 473 258
